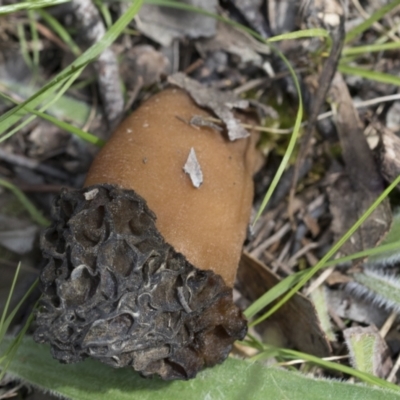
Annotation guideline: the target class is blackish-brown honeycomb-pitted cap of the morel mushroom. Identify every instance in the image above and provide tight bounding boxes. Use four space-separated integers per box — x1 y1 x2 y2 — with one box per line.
34 184 247 380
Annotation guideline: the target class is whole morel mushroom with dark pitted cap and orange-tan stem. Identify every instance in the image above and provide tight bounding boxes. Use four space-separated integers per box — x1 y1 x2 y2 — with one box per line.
34 89 255 379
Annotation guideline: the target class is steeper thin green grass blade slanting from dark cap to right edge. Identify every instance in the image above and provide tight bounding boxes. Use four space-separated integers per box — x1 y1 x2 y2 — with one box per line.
249 176 400 327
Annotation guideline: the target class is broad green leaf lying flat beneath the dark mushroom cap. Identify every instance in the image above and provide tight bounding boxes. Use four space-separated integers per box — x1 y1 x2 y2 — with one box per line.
3 337 400 400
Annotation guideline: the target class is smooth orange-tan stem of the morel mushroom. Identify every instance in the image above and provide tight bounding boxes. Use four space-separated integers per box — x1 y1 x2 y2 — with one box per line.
85 89 255 287
